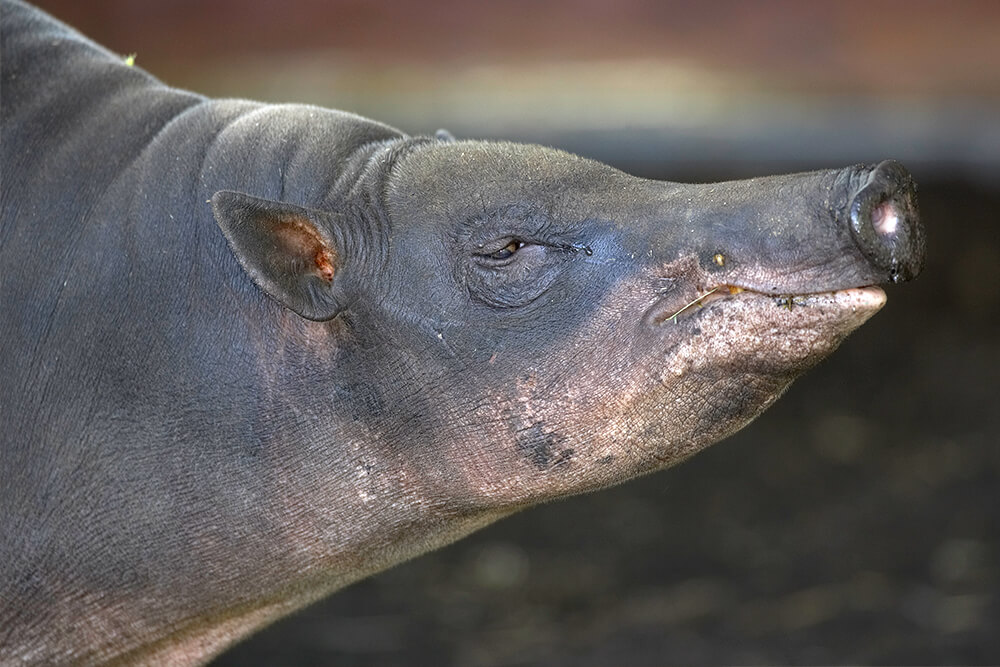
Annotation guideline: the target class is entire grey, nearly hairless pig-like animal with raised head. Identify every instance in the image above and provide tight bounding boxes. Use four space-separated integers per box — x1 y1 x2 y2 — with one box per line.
0 1 923 665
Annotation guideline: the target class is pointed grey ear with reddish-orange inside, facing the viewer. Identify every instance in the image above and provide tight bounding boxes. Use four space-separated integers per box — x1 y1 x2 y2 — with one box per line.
212 191 341 321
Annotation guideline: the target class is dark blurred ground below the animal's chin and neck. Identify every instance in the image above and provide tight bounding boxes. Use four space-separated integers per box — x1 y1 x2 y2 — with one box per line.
215 173 1000 667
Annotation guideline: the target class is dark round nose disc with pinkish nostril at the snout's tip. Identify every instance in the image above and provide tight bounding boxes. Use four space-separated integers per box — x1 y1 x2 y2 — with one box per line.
847 160 924 282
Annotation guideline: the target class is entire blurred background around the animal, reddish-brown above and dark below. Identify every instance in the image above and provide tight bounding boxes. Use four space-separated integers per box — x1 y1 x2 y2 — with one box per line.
38 0 1000 666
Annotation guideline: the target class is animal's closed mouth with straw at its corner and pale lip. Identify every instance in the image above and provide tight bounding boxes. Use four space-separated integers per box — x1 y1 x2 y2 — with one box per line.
649 284 886 325
